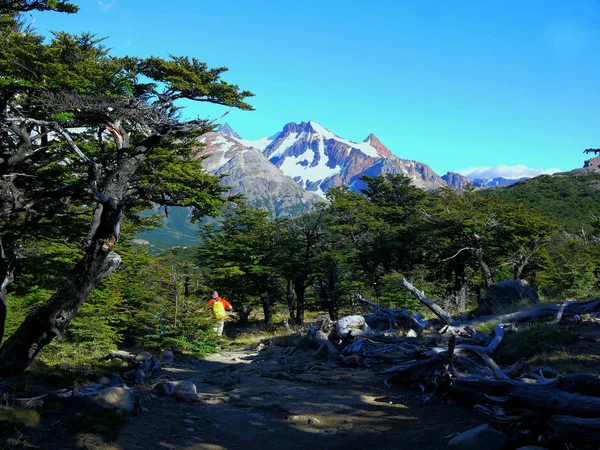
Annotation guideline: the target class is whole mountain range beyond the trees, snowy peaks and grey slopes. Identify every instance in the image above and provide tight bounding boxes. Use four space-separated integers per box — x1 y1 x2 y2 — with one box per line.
139 121 532 245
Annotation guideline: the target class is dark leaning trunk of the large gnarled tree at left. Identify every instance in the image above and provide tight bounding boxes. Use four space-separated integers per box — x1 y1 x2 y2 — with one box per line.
0 133 161 377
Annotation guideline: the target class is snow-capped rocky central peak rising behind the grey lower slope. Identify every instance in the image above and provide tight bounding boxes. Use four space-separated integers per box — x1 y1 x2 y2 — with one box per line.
224 121 446 196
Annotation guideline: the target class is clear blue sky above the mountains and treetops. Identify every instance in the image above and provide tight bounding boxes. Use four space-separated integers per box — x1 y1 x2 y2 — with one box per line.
34 0 600 176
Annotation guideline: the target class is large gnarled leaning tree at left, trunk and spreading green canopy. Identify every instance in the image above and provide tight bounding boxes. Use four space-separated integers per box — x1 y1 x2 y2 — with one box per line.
0 11 252 376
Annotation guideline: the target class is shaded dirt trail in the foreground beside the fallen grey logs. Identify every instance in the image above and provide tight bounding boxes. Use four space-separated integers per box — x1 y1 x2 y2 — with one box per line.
116 347 484 450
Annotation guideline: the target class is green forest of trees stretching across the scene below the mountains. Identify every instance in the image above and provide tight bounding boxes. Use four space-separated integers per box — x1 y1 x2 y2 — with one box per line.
0 0 600 450
